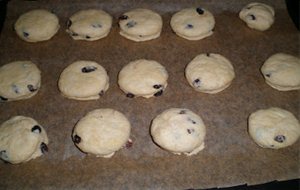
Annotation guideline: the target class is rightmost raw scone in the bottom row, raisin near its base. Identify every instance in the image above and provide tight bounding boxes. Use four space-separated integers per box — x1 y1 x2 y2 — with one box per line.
248 107 300 149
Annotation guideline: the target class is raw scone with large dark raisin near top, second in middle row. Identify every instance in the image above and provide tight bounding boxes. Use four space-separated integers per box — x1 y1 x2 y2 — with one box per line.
58 61 109 100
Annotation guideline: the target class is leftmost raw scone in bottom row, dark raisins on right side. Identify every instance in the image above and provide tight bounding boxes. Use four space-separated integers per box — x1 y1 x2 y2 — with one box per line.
0 116 48 164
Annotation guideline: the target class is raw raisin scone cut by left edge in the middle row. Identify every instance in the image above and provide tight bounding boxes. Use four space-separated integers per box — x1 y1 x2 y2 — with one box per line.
0 61 41 102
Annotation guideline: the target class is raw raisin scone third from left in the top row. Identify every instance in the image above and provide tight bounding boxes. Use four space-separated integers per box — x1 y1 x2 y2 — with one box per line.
119 9 163 42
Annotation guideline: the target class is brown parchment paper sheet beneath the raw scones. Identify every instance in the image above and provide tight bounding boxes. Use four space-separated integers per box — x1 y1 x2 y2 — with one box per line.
0 0 300 189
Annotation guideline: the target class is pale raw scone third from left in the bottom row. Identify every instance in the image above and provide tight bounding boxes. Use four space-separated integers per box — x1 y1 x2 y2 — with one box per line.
151 108 206 156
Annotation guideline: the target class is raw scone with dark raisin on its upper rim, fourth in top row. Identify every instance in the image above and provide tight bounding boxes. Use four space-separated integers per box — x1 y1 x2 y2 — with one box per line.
170 7 215 40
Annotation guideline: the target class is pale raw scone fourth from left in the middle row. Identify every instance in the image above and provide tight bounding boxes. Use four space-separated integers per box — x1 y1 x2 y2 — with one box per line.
185 53 235 94
